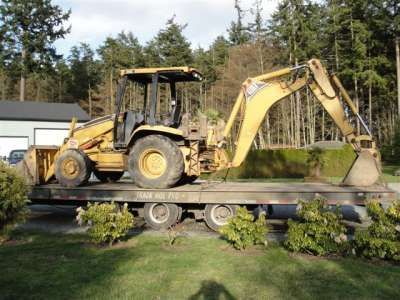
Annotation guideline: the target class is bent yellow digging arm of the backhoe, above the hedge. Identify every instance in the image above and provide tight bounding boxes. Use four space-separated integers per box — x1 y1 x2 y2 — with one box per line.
223 59 379 185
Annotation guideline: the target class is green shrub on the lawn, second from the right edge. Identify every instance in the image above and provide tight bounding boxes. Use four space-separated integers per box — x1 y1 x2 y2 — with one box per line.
285 198 347 255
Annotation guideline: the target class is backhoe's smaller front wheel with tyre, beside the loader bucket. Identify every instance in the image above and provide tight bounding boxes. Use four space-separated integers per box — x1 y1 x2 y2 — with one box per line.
55 149 92 187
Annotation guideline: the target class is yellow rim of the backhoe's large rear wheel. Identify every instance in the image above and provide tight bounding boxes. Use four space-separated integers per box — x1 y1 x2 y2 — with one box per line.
139 149 167 178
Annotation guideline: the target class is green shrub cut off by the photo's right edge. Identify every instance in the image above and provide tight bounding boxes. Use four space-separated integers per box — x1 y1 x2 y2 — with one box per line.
354 201 400 261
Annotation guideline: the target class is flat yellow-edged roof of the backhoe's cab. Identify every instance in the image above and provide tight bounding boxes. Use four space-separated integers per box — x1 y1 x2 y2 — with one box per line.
120 66 203 83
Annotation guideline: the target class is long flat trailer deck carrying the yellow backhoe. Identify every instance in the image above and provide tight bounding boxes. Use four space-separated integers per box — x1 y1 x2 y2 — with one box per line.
29 181 397 205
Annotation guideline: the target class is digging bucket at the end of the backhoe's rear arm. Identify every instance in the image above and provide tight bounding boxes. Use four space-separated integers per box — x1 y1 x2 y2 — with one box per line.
342 150 381 186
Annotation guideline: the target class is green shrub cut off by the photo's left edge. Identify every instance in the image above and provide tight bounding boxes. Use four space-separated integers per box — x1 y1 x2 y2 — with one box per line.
0 162 28 243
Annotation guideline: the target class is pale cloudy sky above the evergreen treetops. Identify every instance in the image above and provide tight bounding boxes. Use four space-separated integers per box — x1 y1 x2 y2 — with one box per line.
53 0 278 54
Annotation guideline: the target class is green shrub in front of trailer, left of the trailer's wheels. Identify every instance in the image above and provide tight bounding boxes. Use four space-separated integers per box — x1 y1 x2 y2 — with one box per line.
76 202 134 246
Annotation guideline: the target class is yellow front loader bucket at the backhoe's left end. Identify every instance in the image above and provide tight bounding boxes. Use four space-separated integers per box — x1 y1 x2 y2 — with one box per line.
16 146 59 185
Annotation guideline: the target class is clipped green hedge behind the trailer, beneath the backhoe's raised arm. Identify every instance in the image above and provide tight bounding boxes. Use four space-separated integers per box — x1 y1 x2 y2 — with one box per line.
210 145 356 179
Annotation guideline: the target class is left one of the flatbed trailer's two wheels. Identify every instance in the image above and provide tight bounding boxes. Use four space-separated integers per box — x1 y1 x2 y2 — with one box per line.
144 203 179 230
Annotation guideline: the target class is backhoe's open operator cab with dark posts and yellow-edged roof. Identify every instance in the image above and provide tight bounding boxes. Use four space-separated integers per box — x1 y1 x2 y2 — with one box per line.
114 67 203 148
